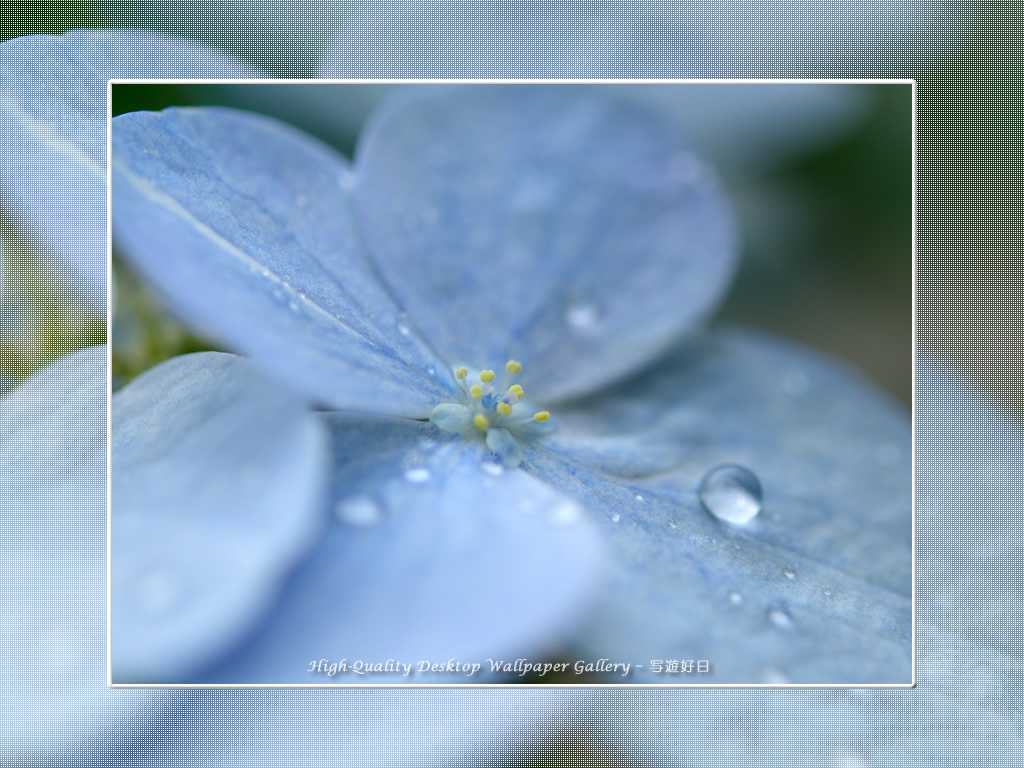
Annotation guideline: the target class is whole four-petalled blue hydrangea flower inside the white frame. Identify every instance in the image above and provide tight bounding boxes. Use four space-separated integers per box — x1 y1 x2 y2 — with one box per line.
112 87 911 683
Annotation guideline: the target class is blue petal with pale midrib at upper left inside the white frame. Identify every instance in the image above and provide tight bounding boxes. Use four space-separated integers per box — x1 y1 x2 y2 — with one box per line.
112 110 452 418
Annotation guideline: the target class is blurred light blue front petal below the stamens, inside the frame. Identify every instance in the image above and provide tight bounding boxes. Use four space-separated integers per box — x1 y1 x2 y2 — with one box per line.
203 416 603 684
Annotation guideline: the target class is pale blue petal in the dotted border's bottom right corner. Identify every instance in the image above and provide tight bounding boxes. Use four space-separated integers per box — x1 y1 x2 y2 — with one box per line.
600 354 1024 768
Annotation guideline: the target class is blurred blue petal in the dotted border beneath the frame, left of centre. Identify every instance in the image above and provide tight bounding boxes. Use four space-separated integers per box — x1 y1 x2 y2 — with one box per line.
114 686 580 768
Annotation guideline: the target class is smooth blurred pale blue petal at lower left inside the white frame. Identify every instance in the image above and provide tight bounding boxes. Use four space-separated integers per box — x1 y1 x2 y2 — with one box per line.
111 352 328 683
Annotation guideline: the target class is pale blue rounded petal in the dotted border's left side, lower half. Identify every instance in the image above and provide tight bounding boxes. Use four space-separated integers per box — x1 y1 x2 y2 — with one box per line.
0 347 170 765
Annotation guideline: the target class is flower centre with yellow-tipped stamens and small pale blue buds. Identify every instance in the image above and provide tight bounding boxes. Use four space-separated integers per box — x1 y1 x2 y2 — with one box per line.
430 360 551 467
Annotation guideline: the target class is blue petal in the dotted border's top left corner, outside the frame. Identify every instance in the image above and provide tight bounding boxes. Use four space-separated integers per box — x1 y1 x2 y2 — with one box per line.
0 31 260 311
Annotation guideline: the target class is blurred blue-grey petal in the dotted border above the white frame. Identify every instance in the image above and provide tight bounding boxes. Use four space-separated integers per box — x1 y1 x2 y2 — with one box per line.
329 0 959 78
